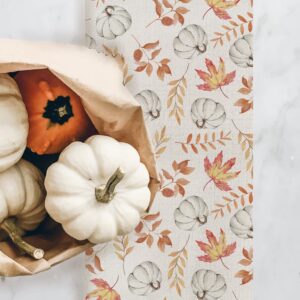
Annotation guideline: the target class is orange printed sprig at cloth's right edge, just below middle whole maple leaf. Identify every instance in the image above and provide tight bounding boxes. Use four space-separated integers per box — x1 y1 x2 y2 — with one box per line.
211 183 253 219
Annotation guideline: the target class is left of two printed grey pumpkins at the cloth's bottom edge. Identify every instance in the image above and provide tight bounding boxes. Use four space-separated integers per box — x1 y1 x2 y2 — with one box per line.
128 261 162 296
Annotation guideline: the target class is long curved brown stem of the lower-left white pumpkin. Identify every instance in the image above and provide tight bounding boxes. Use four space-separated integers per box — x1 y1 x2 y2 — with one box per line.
0 219 44 259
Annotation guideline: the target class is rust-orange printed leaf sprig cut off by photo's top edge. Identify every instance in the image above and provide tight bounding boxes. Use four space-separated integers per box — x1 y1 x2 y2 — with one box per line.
146 0 191 28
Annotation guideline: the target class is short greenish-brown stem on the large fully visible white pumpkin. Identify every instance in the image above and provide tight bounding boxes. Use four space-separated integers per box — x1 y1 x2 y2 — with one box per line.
95 168 125 203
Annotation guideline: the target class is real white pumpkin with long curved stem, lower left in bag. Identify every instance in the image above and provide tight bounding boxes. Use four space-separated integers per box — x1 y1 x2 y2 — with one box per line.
0 160 46 259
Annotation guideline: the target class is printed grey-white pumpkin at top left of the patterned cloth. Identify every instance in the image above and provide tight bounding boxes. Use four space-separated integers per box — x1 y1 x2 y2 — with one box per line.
96 5 131 40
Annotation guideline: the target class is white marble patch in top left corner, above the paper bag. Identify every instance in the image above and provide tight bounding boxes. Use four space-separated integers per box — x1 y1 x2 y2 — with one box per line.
0 0 85 44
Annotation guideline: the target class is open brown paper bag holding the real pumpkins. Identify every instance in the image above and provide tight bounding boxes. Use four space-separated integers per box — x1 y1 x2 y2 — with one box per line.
0 40 159 276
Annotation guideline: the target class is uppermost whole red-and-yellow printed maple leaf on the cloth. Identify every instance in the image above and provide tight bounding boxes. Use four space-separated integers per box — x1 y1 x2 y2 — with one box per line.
196 58 235 98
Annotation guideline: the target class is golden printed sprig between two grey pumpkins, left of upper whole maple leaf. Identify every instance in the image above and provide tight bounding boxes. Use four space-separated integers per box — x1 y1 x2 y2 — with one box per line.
167 64 190 125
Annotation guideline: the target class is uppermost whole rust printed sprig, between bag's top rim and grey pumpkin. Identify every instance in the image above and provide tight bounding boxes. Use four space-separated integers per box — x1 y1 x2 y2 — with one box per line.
132 36 172 81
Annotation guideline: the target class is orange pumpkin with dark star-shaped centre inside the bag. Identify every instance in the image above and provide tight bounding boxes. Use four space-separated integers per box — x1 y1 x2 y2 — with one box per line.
15 69 95 154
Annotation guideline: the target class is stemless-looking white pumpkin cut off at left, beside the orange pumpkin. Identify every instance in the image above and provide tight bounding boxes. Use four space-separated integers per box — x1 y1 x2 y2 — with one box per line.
0 74 28 172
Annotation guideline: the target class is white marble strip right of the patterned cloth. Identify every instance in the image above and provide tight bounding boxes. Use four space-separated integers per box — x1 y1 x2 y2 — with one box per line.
254 0 300 300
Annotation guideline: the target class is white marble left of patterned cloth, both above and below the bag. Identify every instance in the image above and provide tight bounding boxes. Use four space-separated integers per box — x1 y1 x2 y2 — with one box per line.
0 0 86 300
